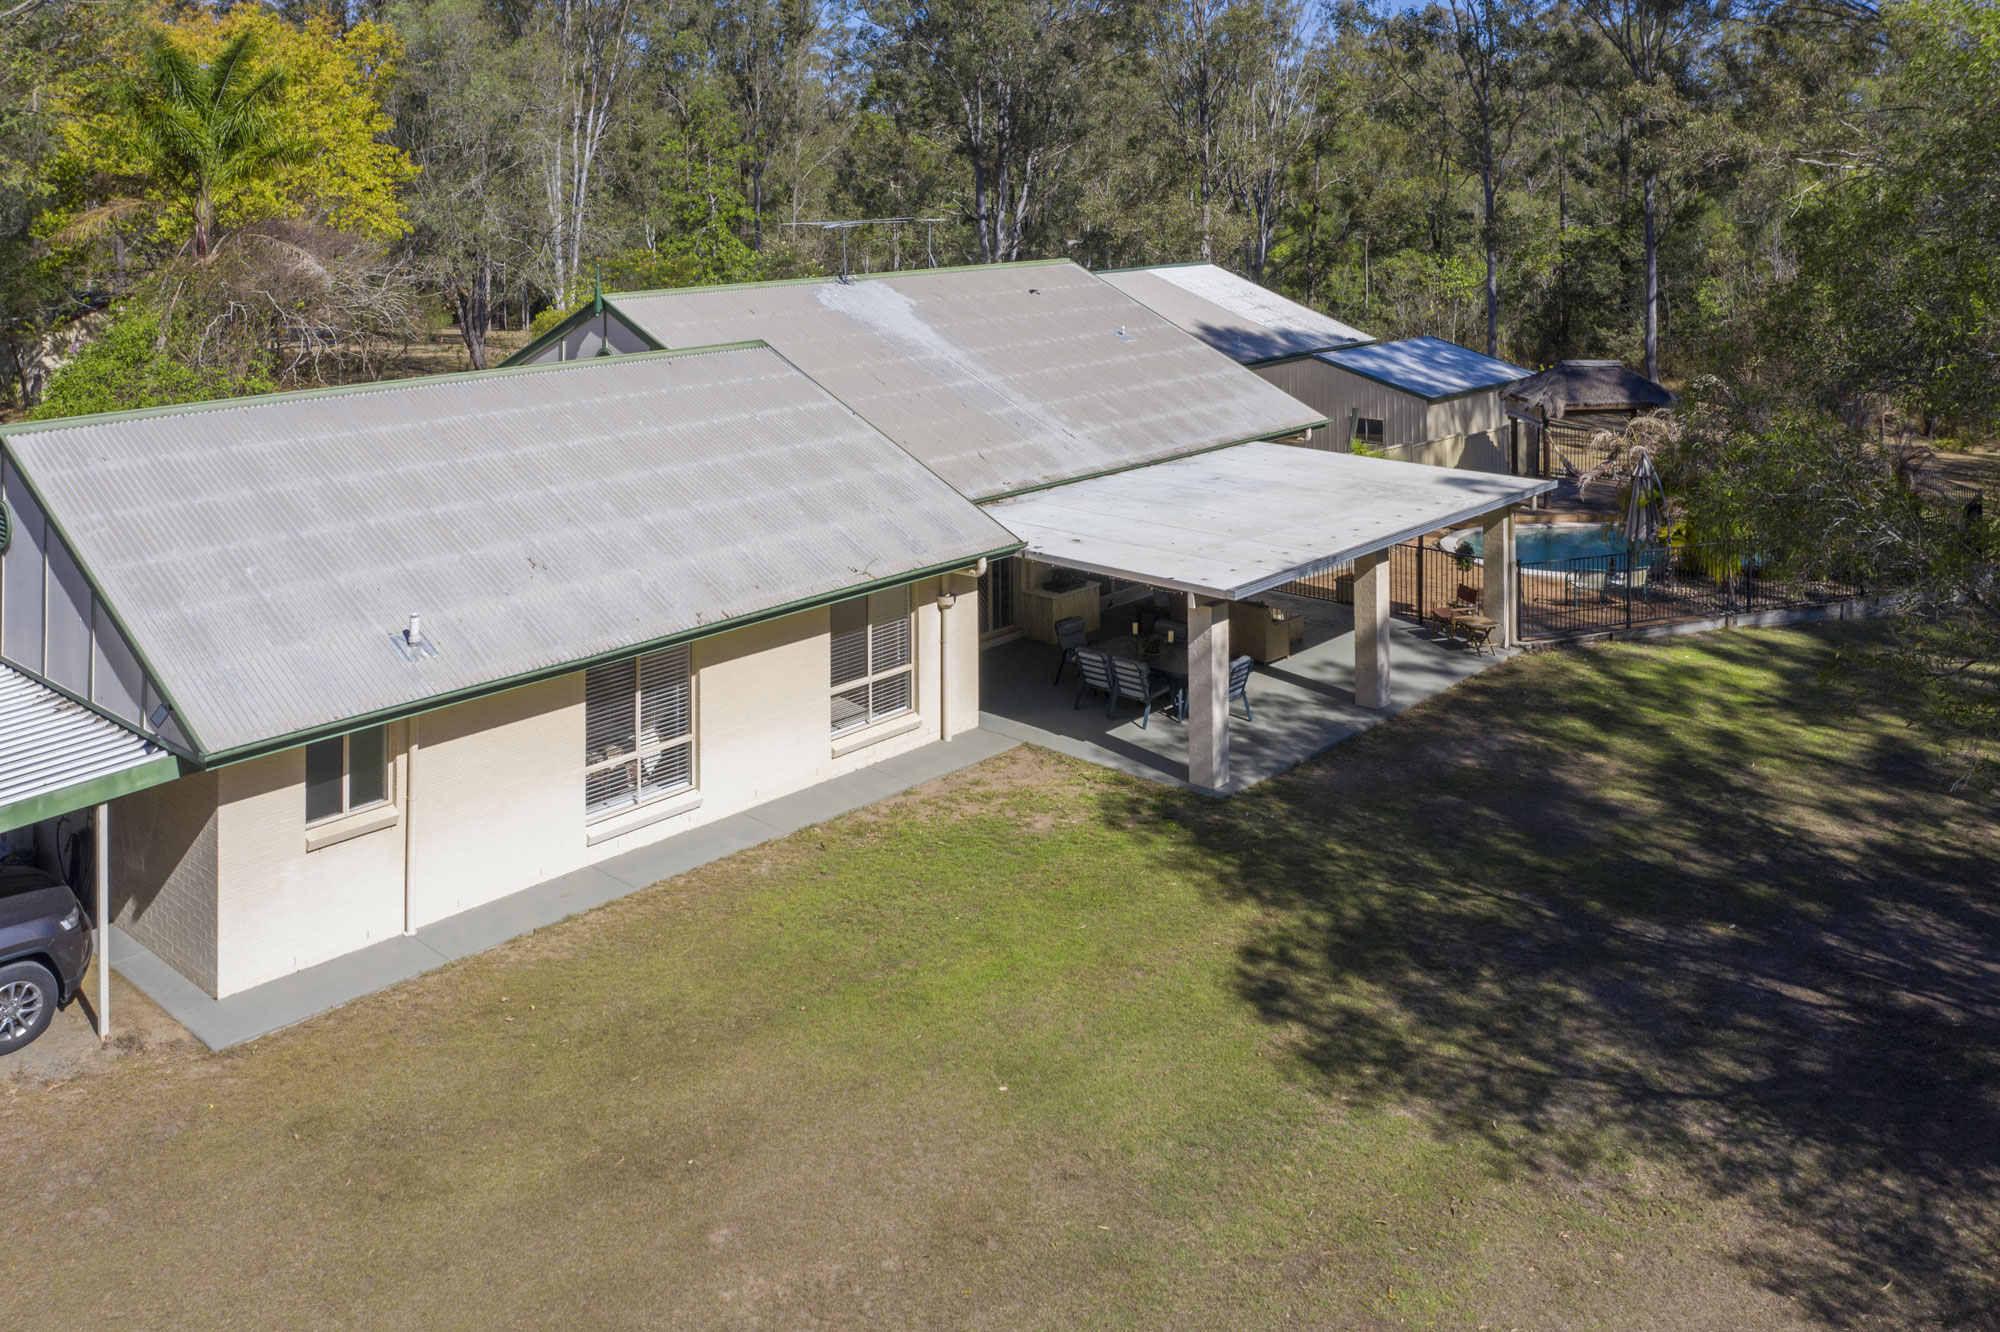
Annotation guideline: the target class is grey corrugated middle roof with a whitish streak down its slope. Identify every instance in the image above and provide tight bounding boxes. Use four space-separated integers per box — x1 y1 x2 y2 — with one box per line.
606 264 1320 500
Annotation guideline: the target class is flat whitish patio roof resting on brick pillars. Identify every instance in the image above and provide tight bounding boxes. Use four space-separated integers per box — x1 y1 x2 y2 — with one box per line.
988 444 1556 600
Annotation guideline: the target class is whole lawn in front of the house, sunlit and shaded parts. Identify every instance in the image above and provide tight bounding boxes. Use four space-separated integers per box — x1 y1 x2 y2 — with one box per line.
0 632 2000 1332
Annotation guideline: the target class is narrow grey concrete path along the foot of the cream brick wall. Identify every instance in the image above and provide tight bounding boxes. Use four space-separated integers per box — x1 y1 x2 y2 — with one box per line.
110 730 1018 1050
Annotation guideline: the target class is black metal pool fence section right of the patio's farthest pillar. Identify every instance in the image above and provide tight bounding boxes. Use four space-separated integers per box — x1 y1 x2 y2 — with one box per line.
1516 546 1860 638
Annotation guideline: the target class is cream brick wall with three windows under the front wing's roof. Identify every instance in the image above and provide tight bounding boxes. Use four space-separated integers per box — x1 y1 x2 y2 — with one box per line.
112 578 978 996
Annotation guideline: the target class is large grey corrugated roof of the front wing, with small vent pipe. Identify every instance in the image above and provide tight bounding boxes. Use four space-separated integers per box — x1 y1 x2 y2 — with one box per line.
6 346 1016 758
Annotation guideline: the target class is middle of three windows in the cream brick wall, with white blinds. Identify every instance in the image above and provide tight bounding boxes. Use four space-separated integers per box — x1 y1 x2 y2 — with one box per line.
584 644 694 816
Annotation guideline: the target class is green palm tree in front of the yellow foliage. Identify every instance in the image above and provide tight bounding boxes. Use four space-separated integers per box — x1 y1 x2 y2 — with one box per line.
124 30 310 260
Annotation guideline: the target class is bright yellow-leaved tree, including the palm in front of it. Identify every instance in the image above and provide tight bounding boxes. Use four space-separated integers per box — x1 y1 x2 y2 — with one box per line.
46 8 416 256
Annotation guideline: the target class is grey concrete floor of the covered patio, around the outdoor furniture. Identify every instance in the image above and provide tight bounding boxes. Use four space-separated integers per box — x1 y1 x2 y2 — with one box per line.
980 594 1512 796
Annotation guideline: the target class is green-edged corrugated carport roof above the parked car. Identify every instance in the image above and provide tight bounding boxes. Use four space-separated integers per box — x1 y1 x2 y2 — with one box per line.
0 666 180 832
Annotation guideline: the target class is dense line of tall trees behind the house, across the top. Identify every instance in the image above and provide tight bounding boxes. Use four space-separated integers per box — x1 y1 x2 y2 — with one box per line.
0 0 2000 428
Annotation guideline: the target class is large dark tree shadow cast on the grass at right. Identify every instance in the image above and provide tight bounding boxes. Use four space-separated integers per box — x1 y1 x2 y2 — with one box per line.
1108 634 2000 1326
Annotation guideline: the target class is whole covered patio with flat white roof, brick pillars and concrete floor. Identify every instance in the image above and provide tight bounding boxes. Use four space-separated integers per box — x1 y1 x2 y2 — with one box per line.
982 442 1552 792
